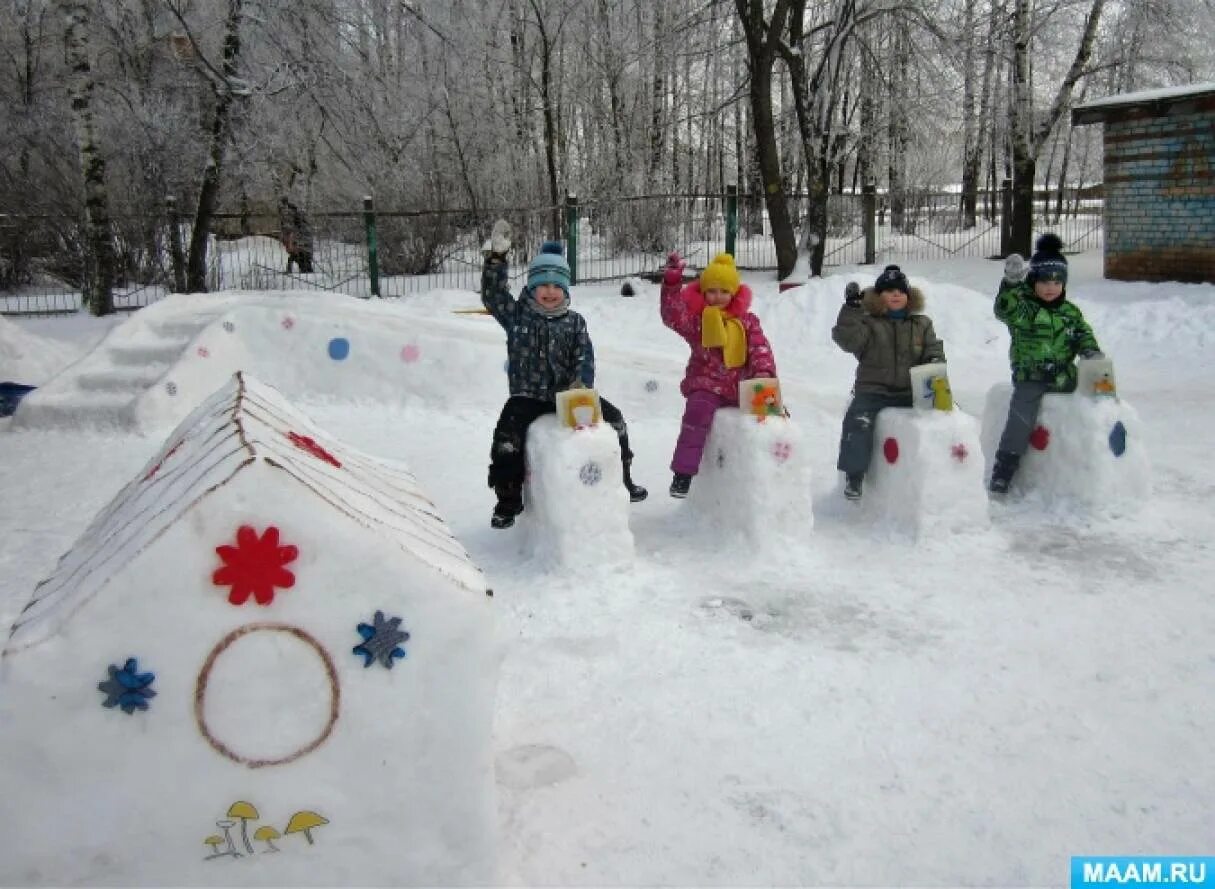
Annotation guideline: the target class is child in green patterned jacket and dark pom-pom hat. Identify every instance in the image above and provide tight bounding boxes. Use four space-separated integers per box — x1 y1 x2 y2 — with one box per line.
988 234 1104 494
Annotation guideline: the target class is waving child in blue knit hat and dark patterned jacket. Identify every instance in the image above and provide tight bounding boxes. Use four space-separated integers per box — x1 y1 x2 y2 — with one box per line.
481 220 648 528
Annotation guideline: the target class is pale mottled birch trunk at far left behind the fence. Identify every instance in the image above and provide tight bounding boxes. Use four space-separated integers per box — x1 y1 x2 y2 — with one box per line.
61 0 114 315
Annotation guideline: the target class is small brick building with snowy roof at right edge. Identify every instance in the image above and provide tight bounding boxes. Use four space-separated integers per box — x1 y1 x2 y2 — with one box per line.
1072 83 1215 282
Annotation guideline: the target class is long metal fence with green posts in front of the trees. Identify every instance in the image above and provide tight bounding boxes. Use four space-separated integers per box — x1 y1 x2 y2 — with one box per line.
0 185 1103 315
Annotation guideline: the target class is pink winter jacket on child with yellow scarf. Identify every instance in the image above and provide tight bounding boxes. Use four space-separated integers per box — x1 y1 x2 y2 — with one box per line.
662 281 776 404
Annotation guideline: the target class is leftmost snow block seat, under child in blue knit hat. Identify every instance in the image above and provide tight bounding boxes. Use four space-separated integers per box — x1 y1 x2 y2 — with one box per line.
520 414 633 567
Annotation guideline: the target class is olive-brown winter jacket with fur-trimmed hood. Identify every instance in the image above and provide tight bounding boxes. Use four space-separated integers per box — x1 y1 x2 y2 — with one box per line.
831 287 945 395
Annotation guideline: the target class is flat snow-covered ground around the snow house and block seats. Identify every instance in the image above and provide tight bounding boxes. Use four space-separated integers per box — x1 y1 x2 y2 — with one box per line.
0 254 1215 887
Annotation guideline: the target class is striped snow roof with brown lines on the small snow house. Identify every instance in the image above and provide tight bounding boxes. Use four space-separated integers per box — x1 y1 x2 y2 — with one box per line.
5 373 486 653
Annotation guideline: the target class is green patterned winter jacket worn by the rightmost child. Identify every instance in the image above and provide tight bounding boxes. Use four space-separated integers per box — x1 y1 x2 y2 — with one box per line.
995 281 1101 392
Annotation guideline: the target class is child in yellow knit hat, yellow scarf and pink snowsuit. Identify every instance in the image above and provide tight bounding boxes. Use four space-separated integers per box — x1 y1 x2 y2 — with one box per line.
661 253 776 497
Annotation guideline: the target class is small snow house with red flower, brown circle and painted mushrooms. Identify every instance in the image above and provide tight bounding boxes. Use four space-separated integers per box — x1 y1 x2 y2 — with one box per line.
0 374 501 887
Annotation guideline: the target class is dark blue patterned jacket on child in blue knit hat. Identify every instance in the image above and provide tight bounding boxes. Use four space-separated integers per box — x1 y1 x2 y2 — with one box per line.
481 260 595 401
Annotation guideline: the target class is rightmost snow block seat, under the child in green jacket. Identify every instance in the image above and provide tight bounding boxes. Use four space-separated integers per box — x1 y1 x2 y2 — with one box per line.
983 383 1152 511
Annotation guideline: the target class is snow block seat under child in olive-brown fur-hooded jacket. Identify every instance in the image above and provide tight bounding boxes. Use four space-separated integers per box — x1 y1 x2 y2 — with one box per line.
841 408 990 537
